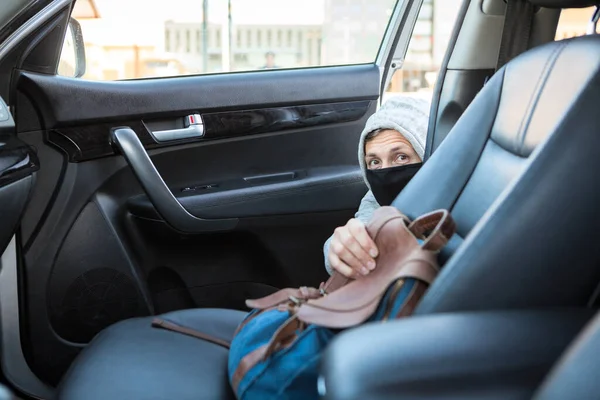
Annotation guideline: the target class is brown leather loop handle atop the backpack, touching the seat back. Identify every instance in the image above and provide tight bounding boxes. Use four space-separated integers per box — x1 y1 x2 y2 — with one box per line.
408 210 456 251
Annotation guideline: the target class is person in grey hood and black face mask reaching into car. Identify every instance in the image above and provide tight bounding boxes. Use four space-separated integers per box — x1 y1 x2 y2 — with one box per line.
323 95 429 278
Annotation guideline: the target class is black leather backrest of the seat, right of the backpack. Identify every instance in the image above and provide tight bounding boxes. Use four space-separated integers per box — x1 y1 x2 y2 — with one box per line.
394 35 600 313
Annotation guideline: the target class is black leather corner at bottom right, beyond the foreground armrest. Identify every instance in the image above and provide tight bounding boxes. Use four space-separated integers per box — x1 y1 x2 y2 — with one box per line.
535 314 600 400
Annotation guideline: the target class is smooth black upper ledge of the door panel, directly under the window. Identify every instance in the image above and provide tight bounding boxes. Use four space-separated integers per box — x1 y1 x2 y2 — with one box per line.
17 64 379 129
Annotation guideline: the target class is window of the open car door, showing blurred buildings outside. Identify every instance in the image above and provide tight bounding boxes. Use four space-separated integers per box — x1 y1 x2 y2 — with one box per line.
59 0 403 80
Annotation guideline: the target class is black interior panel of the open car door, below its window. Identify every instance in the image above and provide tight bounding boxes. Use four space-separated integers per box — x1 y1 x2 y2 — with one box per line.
15 61 379 383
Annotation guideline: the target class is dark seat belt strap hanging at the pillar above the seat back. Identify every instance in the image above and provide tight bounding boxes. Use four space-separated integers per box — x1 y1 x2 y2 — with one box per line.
496 0 535 71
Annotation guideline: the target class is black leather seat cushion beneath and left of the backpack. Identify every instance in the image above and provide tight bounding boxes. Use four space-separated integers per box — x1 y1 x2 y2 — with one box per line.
58 309 245 400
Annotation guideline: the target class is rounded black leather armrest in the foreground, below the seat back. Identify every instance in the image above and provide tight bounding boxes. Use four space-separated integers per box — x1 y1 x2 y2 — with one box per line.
321 310 593 400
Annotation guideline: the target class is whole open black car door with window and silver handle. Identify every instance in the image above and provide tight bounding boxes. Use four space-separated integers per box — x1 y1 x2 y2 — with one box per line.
0 0 434 394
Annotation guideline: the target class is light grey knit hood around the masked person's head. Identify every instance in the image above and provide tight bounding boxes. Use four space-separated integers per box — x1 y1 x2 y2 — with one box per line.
358 95 430 186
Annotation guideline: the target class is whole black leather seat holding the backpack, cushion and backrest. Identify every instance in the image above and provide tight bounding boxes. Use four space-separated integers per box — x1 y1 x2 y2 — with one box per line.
59 0 600 400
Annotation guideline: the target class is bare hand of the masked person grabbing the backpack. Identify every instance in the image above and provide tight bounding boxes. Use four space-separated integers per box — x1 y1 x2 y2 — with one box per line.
327 218 379 279
